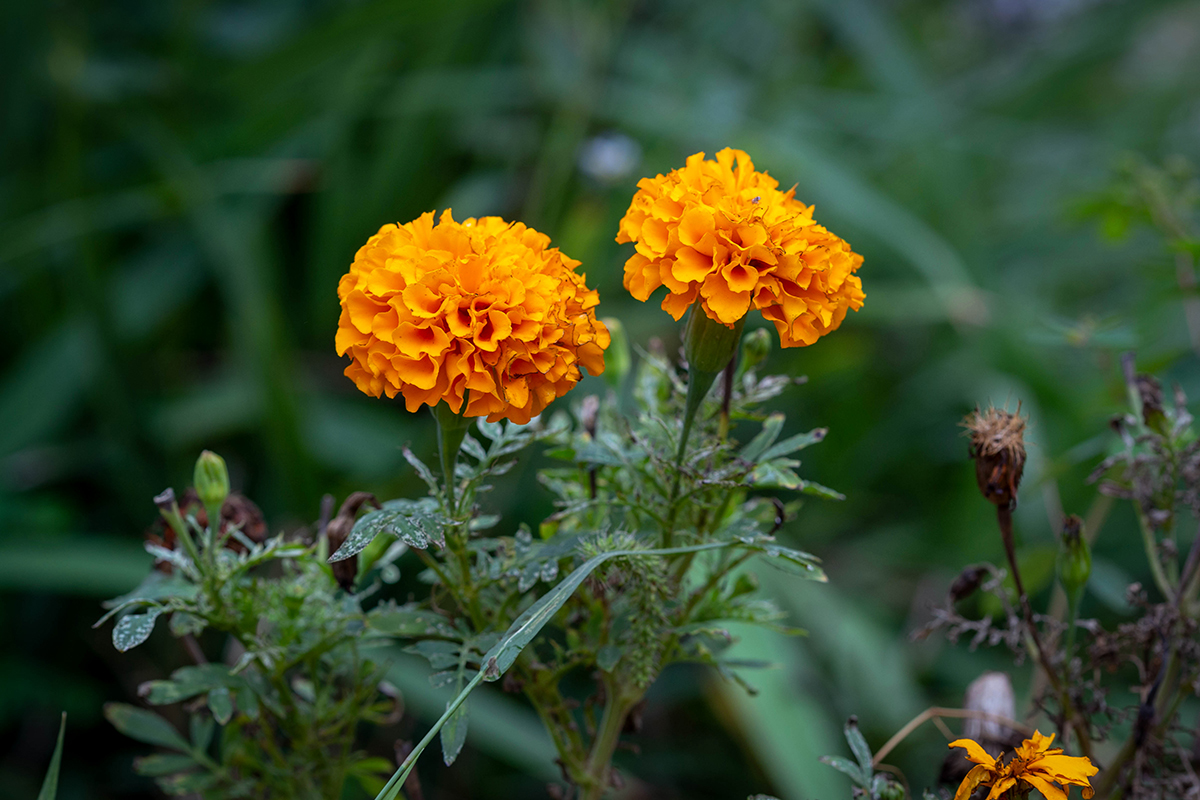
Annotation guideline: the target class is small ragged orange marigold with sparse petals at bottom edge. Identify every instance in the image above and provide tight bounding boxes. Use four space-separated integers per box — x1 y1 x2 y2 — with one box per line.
950 730 1099 800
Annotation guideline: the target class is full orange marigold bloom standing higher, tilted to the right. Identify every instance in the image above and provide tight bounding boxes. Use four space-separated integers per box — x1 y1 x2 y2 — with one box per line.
617 148 865 347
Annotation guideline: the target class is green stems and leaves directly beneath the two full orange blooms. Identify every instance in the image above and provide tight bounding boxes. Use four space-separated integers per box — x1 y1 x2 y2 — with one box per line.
334 333 840 798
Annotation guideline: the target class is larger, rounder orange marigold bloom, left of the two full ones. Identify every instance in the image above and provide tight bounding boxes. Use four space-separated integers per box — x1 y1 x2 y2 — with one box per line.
336 209 608 423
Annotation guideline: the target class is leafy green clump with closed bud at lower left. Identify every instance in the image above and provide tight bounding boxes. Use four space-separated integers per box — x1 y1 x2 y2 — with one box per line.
97 484 396 799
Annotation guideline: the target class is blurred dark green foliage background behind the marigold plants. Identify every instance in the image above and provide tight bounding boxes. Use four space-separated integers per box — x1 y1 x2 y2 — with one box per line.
0 0 1200 800
